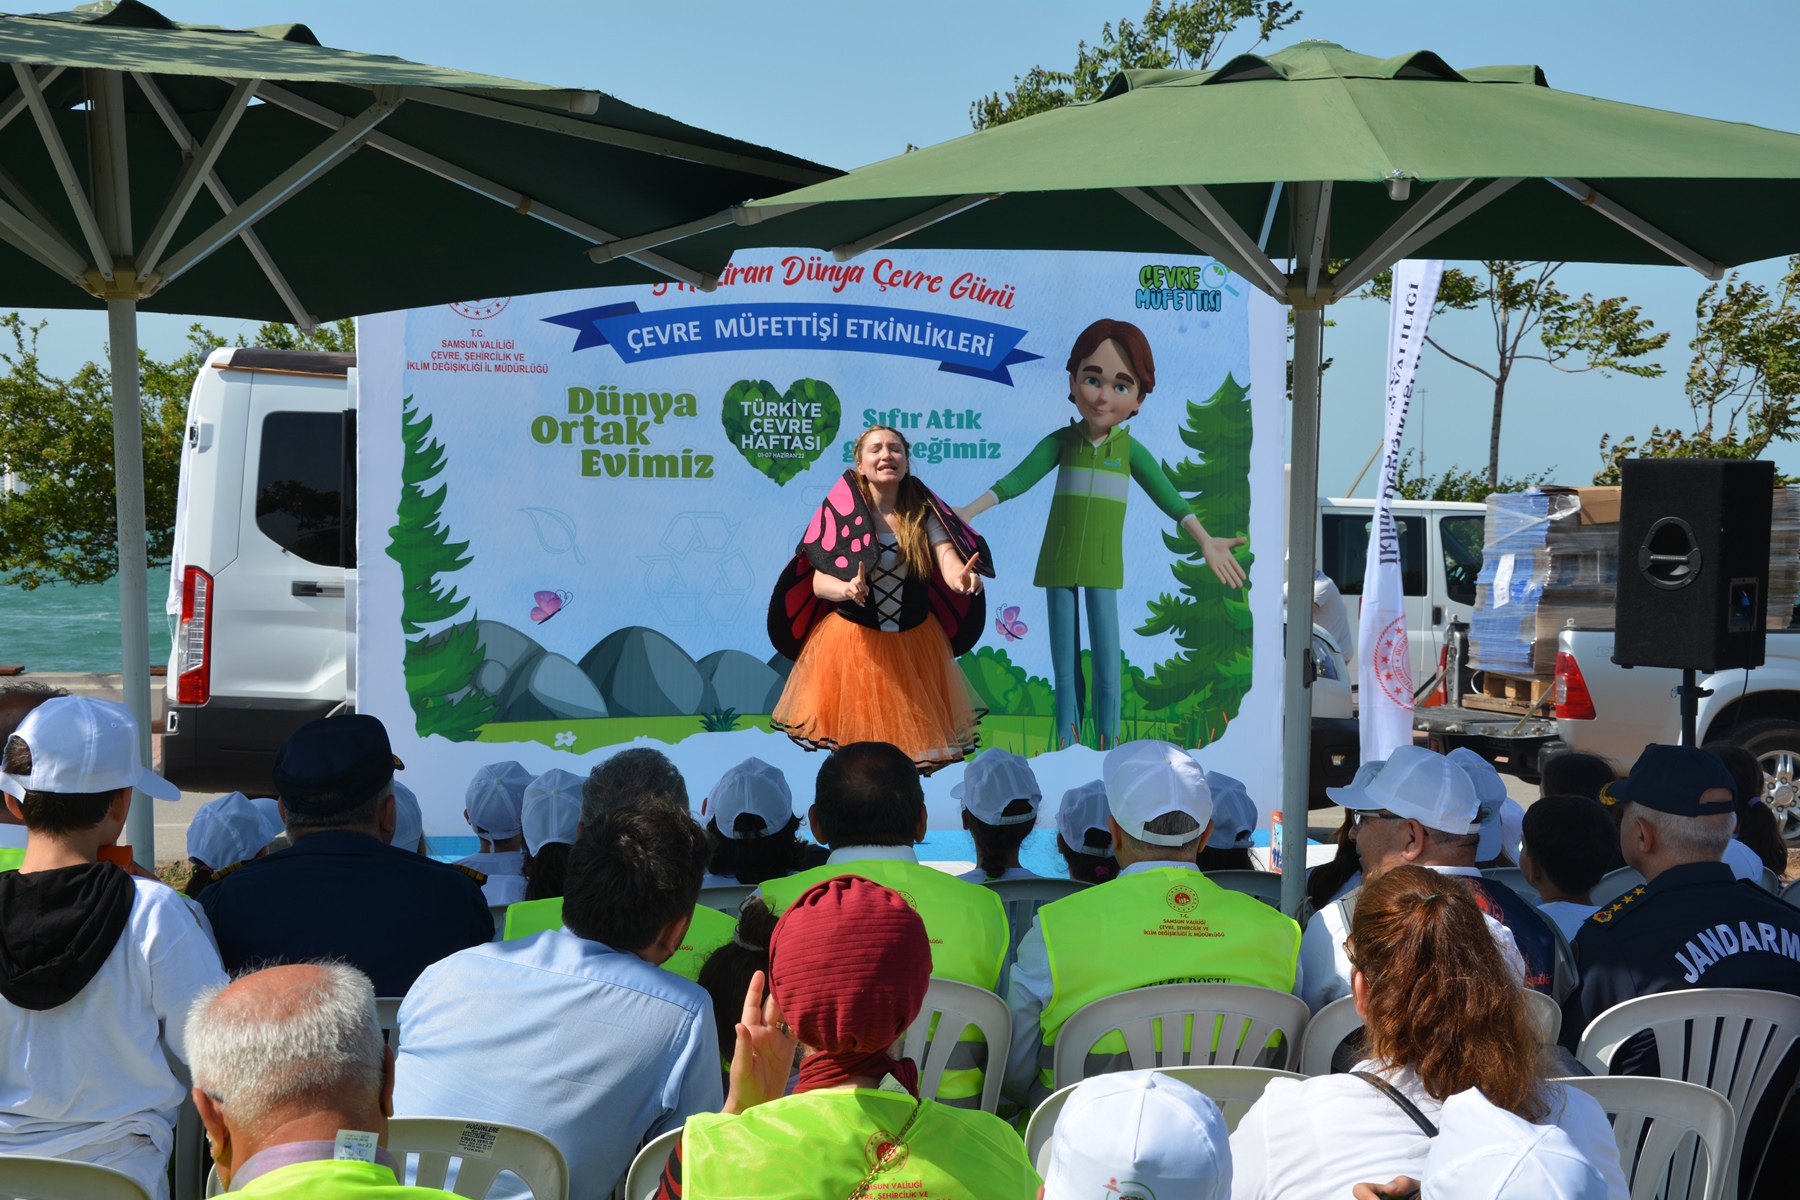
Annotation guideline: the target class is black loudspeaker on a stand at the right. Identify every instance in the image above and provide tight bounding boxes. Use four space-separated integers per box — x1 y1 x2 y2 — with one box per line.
1613 459 1775 671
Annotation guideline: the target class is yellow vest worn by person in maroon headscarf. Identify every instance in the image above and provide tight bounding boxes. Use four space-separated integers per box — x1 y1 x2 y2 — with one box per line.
680 1088 1039 1200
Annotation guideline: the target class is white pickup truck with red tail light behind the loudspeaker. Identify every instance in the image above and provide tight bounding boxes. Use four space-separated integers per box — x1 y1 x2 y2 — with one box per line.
1546 628 1800 840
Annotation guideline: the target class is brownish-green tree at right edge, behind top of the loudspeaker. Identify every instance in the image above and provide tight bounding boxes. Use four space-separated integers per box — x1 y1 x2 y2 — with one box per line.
1593 255 1800 484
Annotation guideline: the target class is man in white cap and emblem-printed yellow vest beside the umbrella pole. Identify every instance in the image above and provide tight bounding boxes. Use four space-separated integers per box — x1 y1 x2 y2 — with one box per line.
1006 741 1300 1106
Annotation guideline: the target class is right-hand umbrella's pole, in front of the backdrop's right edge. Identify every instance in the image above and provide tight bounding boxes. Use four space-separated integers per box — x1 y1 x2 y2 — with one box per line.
1282 308 1325 919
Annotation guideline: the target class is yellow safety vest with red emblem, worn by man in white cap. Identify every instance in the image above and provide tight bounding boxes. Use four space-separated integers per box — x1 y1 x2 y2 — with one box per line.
1037 867 1300 1094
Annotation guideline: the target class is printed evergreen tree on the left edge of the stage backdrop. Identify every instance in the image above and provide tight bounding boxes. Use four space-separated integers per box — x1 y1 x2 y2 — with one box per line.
387 396 497 741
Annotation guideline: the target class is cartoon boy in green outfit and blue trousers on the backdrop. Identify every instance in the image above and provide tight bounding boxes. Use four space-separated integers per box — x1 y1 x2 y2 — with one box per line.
956 320 1244 747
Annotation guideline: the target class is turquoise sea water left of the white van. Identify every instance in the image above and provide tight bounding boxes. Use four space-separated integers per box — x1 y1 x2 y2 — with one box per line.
0 567 169 675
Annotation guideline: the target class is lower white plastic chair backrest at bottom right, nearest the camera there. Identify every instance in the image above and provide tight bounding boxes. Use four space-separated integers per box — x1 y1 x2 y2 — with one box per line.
1557 1076 1737 1200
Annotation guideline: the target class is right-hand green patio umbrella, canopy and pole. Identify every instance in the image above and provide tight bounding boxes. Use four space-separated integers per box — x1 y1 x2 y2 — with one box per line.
619 41 1800 912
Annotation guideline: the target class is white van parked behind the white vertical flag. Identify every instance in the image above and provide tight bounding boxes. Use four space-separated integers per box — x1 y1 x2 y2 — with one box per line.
1318 500 1487 684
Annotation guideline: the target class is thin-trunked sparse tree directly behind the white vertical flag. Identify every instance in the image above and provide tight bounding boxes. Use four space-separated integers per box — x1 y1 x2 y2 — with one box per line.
1366 259 1669 491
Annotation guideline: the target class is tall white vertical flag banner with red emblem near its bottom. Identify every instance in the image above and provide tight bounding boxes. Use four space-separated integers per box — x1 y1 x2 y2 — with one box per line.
1357 259 1444 763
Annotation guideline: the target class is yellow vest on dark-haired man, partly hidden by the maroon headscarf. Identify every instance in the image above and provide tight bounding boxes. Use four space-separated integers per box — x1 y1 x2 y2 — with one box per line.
763 858 1012 1108
